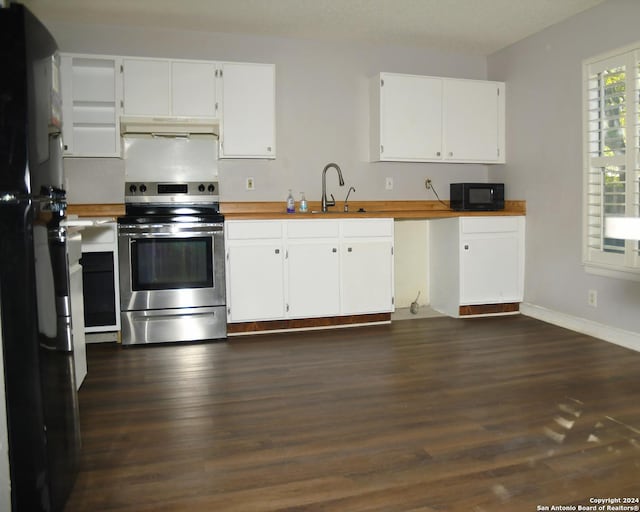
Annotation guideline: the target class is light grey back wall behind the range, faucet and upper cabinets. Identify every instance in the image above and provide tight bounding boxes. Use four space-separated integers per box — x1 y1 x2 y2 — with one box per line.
43 19 487 203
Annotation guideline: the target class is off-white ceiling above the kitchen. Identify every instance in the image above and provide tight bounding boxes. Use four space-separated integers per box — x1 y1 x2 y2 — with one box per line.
23 0 604 55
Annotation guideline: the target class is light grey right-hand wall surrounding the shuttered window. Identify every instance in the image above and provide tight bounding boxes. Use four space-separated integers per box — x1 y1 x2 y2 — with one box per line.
488 0 640 333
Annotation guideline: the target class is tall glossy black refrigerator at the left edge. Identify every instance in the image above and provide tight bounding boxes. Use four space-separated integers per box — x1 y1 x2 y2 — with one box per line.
0 4 80 512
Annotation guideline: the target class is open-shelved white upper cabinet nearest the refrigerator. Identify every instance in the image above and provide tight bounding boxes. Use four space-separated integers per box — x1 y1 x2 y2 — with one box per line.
61 53 122 157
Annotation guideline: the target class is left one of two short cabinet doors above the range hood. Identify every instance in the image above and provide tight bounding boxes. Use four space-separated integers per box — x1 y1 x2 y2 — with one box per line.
123 59 171 116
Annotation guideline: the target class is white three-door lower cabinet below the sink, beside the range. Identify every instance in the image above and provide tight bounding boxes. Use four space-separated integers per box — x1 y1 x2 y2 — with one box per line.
225 219 394 323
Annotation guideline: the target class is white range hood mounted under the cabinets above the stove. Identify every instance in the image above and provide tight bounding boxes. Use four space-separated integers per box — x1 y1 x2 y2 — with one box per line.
120 116 220 137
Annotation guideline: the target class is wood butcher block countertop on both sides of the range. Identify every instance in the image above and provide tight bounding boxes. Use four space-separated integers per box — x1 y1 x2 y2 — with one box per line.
67 201 527 220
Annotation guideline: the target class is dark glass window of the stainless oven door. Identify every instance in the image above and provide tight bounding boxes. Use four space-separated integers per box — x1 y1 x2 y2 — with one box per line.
131 237 213 291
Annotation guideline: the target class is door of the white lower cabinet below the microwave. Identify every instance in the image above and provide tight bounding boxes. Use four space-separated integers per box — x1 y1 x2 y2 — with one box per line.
460 232 523 305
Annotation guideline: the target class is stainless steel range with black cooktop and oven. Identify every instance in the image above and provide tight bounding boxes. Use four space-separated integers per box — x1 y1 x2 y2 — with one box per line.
118 181 227 345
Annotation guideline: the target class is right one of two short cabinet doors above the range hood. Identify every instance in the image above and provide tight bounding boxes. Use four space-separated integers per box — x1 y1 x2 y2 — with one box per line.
171 61 218 118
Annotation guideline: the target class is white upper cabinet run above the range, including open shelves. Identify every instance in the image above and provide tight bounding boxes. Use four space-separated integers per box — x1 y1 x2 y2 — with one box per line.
61 54 276 159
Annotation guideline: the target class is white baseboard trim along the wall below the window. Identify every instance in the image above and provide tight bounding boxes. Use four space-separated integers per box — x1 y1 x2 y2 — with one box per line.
520 302 640 352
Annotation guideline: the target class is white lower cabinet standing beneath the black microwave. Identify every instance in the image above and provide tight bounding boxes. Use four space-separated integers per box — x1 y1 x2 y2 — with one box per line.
429 216 525 317
